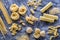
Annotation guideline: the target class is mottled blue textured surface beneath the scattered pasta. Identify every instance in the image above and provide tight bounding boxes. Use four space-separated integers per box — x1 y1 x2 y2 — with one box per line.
0 0 60 40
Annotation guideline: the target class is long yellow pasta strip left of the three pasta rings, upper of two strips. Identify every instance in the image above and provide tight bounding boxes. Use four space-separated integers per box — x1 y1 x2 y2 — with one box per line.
0 1 12 24
